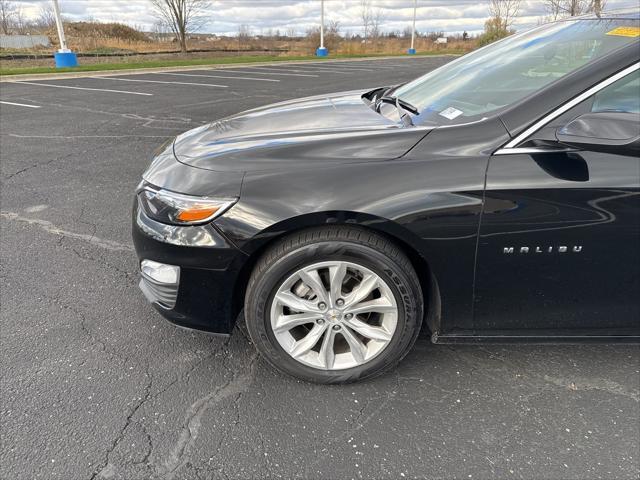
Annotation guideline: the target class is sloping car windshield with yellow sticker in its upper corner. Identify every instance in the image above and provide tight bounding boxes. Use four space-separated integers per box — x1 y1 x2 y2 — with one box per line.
393 19 640 125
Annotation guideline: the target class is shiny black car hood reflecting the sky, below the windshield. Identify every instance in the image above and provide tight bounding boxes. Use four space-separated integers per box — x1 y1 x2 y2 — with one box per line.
173 91 428 171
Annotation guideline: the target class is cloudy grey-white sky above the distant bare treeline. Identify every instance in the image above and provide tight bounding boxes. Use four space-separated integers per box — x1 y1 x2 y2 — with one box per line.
17 0 638 35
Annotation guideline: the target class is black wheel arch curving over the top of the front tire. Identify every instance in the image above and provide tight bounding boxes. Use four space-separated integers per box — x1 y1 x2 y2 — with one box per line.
232 211 441 333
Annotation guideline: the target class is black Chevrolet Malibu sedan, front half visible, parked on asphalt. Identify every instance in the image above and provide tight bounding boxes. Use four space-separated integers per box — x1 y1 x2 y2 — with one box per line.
133 10 640 383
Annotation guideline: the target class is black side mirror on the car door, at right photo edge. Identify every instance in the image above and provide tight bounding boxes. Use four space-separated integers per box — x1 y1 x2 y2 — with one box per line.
556 112 640 155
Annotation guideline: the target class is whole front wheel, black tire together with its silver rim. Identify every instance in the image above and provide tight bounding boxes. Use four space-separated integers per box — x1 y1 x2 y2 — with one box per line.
245 226 424 384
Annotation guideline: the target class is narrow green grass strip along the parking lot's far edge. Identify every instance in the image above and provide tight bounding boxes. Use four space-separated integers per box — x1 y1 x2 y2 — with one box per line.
0 50 465 75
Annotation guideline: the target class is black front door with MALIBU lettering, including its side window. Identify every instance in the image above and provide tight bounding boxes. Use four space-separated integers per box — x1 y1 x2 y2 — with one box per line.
474 70 640 336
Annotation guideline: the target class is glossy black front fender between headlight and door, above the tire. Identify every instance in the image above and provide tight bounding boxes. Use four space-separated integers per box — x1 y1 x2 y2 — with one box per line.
215 156 487 329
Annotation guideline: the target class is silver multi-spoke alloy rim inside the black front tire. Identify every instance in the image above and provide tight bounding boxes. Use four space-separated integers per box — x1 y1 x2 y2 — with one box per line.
271 261 398 370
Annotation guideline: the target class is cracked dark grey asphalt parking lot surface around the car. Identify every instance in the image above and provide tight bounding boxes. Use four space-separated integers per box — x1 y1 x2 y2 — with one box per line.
0 57 640 479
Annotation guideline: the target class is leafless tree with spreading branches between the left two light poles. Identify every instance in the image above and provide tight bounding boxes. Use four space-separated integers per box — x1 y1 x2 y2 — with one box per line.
151 0 210 53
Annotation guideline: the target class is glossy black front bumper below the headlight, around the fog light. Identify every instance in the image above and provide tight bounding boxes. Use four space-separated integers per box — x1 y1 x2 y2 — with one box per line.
132 199 247 334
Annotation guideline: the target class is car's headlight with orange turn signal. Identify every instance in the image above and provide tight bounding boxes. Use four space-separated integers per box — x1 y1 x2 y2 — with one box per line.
138 185 238 225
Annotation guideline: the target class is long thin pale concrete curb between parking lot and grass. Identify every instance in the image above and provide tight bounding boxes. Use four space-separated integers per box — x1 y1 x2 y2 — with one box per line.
0 53 459 83
